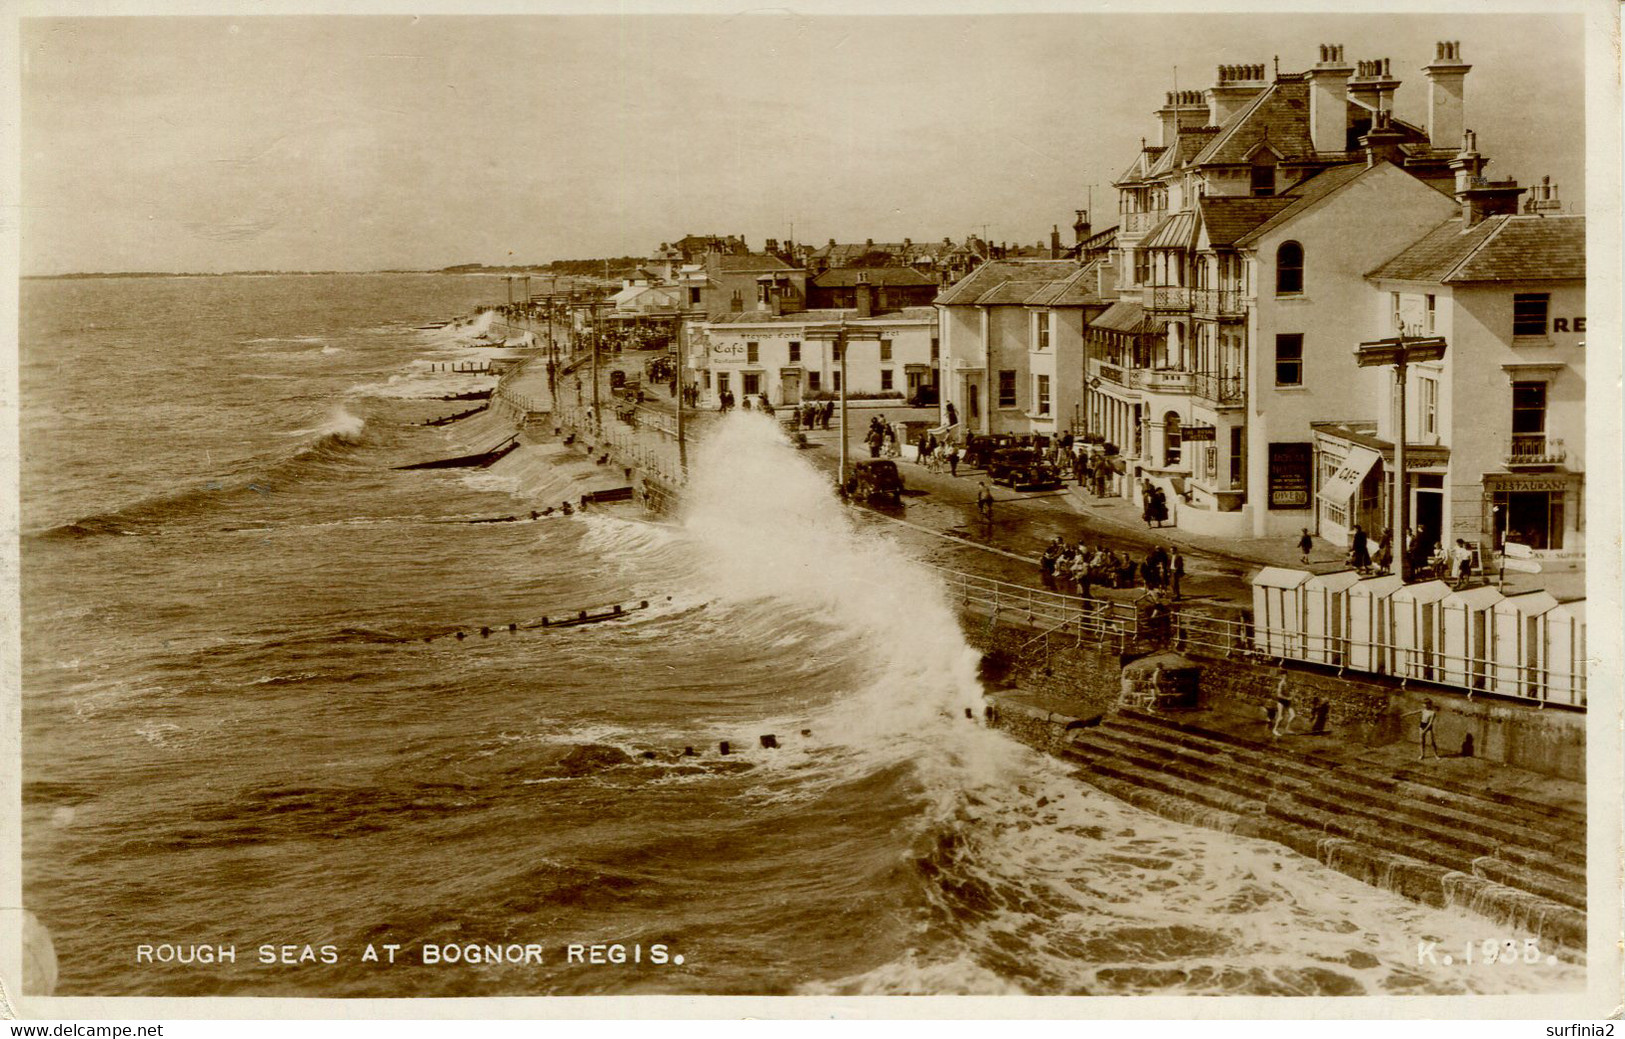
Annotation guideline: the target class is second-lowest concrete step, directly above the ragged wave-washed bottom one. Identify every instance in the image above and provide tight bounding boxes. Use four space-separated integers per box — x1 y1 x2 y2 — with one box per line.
1084 727 1586 909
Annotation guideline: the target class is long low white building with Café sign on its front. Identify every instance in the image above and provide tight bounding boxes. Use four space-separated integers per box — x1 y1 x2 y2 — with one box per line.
689 307 938 408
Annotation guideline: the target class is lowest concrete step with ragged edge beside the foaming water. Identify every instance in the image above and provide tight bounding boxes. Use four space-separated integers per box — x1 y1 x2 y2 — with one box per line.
1063 741 1586 956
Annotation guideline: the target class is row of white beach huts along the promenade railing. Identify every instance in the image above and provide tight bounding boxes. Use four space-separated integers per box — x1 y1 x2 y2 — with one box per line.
1251 566 1586 707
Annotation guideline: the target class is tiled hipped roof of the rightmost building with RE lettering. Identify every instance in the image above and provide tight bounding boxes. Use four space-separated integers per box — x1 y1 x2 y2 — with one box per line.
1367 213 1586 283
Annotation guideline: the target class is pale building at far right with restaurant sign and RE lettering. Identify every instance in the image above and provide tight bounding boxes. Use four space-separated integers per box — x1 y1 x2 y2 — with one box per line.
1345 169 1586 558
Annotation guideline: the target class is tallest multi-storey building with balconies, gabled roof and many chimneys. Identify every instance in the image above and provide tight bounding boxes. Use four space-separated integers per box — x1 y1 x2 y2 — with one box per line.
1084 44 1495 537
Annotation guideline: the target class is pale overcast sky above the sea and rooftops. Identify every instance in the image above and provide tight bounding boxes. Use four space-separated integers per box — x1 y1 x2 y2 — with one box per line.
21 11 1584 273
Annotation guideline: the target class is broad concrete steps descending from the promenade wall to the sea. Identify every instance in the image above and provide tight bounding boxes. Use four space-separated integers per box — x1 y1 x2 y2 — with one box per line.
1061 709 1586 951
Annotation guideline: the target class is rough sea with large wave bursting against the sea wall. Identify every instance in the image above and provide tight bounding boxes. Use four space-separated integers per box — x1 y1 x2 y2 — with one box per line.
20 275 1584 997
